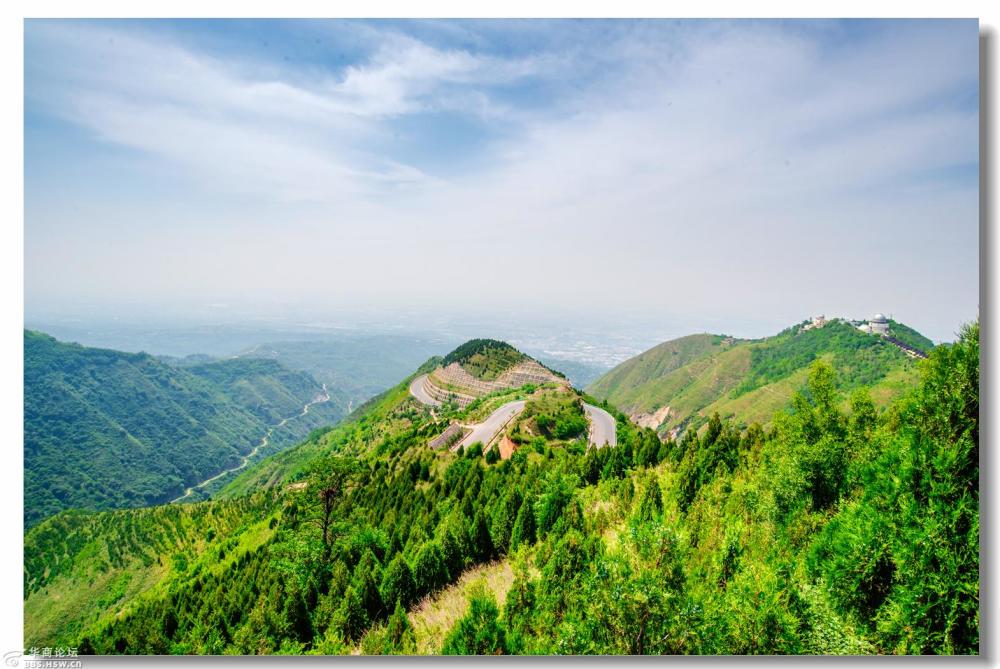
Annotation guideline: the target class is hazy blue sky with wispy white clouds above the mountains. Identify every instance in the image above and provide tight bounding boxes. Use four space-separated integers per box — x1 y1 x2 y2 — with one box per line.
24 20 979 341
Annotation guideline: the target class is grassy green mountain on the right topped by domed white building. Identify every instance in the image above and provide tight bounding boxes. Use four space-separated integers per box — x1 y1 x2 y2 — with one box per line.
587 321 929 433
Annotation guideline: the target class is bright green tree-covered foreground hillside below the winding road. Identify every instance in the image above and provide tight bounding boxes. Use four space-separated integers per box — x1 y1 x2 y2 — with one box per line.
25 325 979 654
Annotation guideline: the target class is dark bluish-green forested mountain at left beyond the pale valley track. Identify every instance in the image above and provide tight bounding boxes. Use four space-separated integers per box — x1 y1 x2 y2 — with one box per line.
24 331 342 525
